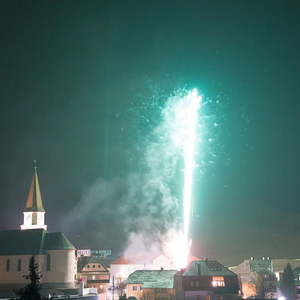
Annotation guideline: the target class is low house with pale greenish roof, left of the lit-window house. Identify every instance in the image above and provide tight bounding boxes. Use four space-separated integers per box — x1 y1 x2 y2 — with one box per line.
126 270 177 300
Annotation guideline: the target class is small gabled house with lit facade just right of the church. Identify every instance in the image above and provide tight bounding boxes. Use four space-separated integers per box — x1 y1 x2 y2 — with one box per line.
77 256 111 294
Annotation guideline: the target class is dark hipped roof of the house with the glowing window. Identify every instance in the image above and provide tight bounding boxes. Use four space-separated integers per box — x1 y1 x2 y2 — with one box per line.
182 260 236 276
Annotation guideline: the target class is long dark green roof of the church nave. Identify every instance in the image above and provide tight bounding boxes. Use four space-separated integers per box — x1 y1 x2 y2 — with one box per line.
0 229 75 255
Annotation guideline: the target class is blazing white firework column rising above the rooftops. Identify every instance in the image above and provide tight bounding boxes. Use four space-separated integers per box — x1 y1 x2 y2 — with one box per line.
159 89 202 269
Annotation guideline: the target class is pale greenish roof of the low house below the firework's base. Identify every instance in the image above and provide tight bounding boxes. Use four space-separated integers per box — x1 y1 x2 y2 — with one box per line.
127 270 177 289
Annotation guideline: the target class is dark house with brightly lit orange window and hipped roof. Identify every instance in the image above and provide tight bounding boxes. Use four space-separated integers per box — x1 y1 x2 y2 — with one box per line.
174 260 240 300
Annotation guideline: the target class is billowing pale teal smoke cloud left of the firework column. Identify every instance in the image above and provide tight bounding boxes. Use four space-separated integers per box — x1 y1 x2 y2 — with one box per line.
65 91 196 262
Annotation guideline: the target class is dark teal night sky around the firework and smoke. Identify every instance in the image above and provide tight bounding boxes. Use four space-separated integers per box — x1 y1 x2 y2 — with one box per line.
0 0 300 264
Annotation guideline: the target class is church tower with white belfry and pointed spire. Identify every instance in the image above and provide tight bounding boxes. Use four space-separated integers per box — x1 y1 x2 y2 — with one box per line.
21 161 47 230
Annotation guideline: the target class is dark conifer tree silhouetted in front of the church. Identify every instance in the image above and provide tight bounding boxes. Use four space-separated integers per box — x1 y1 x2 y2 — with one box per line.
17 256 42 300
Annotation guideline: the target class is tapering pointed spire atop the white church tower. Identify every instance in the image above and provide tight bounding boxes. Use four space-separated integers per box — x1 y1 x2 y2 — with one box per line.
24 160 45 212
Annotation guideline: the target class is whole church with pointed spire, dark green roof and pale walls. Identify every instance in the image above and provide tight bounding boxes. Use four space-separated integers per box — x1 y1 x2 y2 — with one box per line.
0 166 77 295
